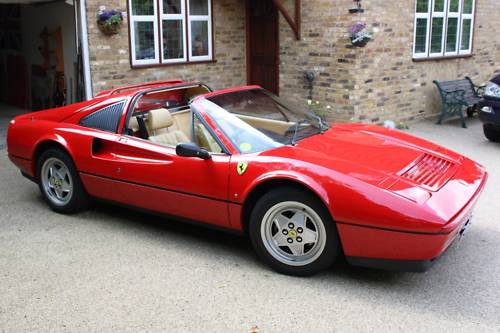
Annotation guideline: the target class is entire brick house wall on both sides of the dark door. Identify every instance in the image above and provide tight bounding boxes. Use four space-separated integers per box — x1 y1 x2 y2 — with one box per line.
87 0 500 123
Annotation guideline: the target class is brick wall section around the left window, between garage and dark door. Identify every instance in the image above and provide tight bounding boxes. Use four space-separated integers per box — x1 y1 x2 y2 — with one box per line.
87 0 246 94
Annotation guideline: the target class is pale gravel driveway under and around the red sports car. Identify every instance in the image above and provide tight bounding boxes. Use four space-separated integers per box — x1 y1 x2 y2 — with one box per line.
0 116 500 333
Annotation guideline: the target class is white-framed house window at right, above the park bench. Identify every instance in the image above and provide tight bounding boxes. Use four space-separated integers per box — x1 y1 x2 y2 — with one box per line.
413 0 475 59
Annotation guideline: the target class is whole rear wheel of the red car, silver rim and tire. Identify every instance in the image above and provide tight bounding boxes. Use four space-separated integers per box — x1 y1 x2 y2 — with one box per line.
37 149 88 214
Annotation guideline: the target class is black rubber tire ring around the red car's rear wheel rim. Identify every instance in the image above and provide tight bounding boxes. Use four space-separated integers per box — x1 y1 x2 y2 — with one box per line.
36 148 89 214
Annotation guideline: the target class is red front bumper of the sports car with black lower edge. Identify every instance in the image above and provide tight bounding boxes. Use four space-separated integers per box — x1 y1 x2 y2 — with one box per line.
337 175 487 272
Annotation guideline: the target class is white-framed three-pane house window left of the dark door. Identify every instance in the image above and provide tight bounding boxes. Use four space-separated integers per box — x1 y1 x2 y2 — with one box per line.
129 0 213 66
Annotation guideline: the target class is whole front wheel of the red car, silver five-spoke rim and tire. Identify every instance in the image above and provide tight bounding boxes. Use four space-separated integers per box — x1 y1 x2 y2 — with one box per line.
249 188 339 276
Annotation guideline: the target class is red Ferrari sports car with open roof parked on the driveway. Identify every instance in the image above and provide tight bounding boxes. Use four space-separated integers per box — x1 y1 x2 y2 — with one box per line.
7 81 487 275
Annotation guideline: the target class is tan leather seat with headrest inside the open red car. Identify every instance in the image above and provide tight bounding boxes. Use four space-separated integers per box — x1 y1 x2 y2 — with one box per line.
147 109 190 146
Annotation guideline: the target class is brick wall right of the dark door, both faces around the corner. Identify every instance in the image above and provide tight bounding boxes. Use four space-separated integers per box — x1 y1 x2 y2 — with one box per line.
280 0 500 123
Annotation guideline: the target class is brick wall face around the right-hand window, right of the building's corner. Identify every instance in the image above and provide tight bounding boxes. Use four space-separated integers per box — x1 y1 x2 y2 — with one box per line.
353 0 500 122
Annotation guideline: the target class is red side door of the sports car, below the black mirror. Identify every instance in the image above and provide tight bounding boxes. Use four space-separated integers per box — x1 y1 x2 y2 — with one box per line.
101 109 230 227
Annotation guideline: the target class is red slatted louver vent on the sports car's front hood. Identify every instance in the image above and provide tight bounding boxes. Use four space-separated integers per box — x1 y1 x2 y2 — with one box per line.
400 154 456 190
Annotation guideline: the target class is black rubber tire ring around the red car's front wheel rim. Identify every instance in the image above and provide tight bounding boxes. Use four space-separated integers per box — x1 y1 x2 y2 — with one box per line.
248 188 340 276
